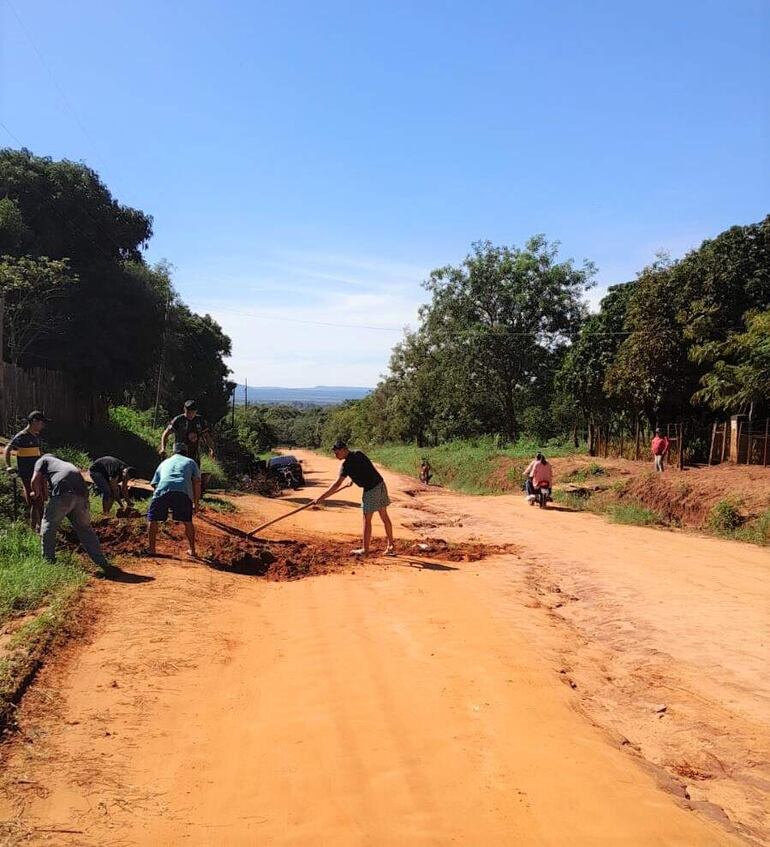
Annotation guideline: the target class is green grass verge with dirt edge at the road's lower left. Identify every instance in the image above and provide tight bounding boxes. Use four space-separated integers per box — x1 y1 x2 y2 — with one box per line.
0 523 88 727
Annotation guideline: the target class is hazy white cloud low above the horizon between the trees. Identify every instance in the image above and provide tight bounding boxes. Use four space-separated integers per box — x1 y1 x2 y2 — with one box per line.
183 250 428 387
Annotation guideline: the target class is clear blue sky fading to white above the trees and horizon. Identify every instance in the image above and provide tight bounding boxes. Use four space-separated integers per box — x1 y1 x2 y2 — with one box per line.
0 0 770 386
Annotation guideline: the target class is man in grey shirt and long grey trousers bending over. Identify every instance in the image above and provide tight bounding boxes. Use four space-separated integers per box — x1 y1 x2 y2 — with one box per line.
32 453 108 568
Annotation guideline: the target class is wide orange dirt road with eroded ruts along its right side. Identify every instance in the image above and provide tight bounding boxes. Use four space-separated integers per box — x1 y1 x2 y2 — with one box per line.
0 454 770 847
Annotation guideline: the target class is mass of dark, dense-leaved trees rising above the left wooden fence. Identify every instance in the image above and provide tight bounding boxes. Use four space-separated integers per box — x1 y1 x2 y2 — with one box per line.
0 149 231 420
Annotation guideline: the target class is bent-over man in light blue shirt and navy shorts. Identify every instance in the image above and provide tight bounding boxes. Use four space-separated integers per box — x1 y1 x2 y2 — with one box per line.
147 442 201 557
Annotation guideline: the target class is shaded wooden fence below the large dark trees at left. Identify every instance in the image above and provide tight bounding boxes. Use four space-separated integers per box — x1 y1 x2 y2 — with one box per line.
0 362 107 435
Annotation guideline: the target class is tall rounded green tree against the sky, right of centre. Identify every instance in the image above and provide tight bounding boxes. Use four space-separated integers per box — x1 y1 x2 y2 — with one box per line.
419 236 595 439
